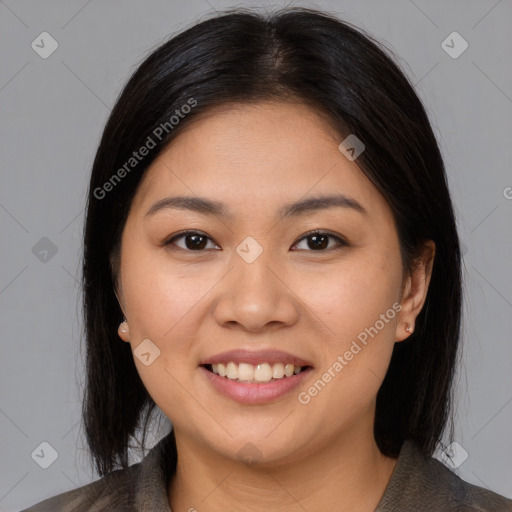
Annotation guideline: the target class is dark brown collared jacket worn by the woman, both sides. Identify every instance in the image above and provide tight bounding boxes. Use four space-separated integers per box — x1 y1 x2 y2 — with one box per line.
22 432 512 512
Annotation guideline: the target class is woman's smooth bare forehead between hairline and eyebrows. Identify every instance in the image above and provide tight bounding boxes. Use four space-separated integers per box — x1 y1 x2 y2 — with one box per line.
132 102 387 222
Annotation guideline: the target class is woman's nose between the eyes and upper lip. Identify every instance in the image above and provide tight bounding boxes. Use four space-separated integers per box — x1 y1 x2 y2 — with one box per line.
214 247 299 332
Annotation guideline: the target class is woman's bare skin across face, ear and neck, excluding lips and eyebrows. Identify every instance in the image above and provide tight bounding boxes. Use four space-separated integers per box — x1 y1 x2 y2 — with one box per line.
117 102 435 512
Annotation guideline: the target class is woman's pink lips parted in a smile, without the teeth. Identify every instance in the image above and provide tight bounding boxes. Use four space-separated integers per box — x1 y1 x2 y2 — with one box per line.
199 349 313 405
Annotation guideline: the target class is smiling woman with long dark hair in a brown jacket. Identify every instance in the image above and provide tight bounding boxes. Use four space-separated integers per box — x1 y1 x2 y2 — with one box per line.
23 8 512 512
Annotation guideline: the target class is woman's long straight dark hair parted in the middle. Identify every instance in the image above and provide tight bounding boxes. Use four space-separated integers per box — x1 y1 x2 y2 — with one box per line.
83 8 461 475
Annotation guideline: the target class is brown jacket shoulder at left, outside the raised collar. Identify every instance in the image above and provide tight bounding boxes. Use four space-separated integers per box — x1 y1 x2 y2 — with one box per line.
21 463 140 512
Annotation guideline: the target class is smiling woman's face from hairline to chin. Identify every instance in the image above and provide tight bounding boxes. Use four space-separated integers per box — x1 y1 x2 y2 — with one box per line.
118 102 428 462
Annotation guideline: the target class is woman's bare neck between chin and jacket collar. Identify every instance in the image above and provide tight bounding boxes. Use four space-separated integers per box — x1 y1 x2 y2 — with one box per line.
169 422 396 512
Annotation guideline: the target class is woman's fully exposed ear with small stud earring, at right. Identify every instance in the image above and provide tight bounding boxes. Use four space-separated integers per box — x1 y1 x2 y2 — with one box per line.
395 240 436 341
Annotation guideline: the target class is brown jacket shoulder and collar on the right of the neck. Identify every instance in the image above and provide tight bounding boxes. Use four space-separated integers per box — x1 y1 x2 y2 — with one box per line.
376 442 512 512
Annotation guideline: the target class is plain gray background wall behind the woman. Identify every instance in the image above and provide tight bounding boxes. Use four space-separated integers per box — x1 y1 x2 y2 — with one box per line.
0 0 512 511
